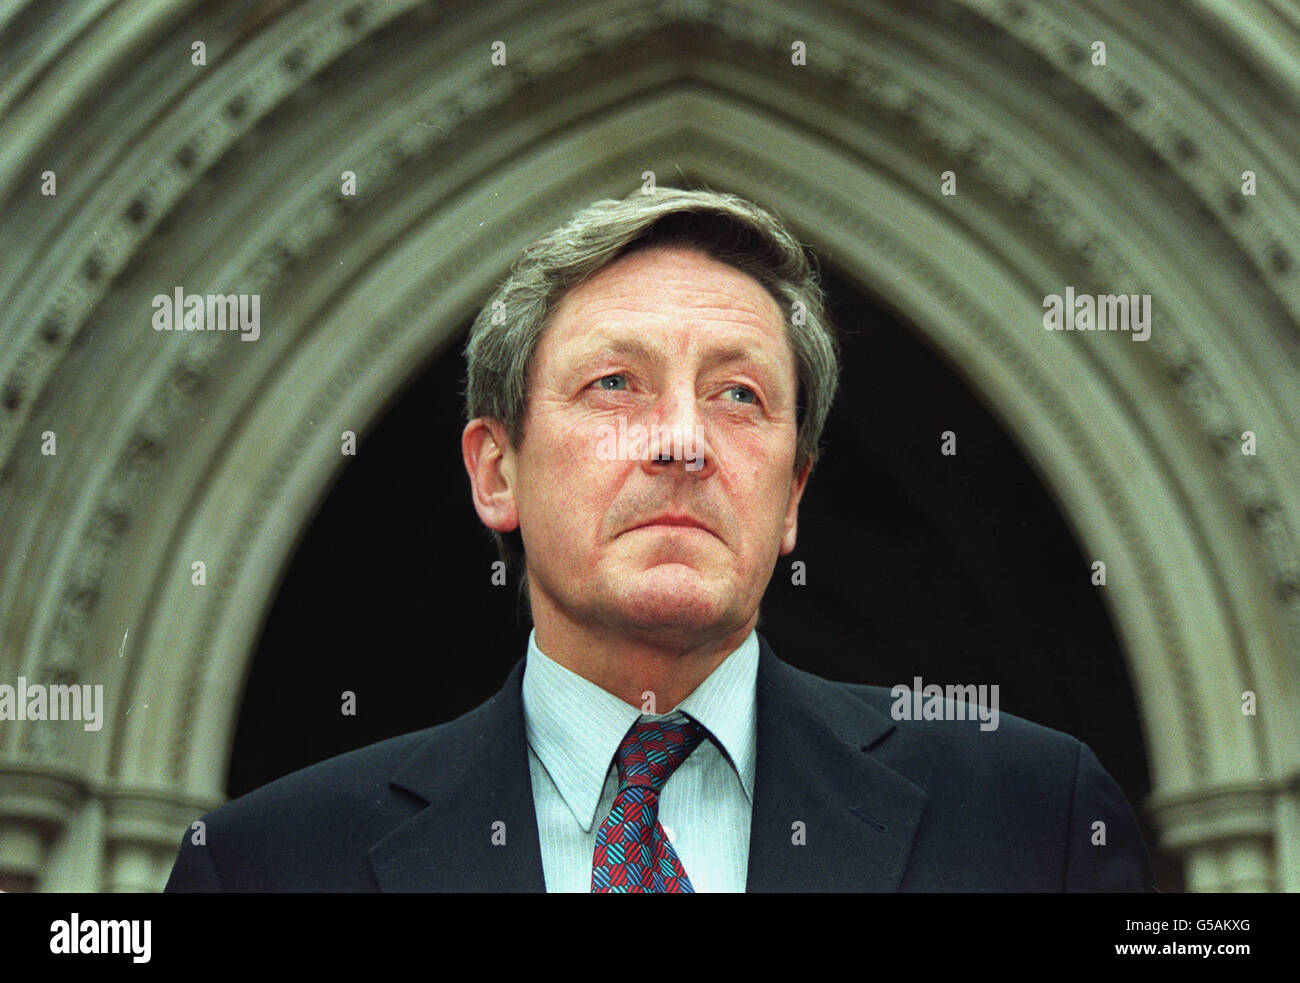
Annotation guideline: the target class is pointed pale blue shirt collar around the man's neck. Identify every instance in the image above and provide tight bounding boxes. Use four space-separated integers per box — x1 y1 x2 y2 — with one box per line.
523 629 758 832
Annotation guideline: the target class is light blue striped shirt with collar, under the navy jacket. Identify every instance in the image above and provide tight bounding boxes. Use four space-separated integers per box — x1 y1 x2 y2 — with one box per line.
523 629 758 893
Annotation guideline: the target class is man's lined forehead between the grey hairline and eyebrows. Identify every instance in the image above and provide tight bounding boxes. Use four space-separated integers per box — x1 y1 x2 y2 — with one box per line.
538 246 790 369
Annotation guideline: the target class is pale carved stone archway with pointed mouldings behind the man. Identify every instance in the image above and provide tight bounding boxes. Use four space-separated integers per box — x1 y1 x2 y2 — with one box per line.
0 0 1300 889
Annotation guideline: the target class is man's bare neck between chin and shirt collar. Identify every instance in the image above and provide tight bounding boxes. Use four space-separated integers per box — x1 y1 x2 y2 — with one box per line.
533 598 758 714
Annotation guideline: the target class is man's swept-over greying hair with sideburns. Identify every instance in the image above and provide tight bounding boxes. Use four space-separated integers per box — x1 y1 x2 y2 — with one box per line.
464 189 840 611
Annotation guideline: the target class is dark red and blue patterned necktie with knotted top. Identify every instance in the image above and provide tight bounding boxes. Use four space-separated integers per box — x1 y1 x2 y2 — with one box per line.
592 716 705 895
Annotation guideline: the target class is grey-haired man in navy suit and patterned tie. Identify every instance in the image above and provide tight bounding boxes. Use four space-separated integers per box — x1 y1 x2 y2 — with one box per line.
168 190 1151 892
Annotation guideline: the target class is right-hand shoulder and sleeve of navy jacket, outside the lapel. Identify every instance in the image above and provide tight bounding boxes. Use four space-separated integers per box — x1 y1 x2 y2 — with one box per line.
805 674 1153 891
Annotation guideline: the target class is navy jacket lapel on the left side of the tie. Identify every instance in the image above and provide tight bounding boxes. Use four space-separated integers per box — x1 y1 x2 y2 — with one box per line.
369 659 546 892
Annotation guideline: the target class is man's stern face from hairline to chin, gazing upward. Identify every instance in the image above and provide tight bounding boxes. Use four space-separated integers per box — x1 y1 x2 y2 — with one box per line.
478 247 809 642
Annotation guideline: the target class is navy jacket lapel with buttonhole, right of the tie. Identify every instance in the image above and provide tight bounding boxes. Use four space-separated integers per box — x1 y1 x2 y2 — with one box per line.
746 635 926 892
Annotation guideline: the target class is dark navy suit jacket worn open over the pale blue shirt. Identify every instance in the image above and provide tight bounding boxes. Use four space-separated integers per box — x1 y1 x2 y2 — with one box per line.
166 636 1153 891
